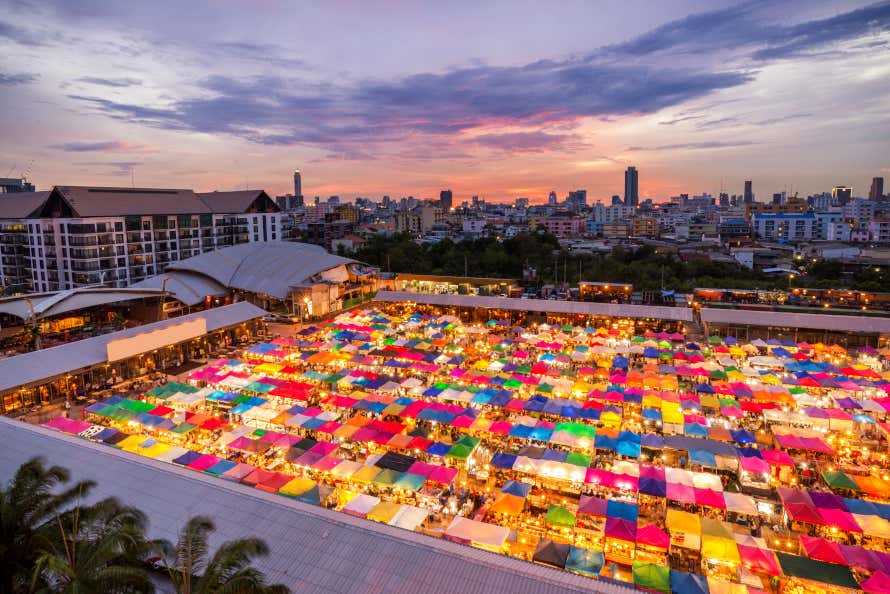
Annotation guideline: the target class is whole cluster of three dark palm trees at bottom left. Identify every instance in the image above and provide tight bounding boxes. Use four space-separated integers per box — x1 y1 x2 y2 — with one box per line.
0 458 289 594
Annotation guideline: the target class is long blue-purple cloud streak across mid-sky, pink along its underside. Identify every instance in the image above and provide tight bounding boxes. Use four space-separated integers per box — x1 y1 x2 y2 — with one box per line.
70 60 753 153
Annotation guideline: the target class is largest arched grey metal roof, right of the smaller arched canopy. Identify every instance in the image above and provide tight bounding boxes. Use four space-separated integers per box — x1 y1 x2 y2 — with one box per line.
162 241 355 299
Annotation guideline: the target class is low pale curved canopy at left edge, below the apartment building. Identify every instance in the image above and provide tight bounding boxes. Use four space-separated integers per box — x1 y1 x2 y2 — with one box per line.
0 287 164 320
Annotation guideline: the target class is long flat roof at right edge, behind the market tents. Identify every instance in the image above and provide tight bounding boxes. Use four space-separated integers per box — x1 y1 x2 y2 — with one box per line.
701 307 890 334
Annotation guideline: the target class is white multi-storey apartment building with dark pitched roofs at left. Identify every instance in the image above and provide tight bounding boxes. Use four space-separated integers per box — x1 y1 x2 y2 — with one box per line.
0 186 282 293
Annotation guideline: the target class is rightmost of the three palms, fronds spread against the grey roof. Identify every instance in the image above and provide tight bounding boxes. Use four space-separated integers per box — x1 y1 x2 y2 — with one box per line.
154 516 289 594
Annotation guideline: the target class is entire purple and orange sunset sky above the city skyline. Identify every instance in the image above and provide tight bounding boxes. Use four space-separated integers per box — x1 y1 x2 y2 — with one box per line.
0 0 890 202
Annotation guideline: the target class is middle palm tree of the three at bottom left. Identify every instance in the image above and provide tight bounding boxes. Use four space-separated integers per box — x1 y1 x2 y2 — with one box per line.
32 498 154 594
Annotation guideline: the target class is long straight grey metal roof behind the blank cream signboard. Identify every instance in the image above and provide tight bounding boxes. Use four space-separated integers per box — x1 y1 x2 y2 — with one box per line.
0 301 266 392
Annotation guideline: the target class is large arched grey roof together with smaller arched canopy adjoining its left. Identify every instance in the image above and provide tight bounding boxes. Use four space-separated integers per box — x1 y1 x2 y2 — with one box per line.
133 241 357 305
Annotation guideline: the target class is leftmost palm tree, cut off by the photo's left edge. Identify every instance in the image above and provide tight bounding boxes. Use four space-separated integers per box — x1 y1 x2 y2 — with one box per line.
0 458 94 592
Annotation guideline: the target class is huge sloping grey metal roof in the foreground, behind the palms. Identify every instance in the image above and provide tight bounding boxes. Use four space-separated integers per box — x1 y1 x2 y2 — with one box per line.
0 418 633 594
